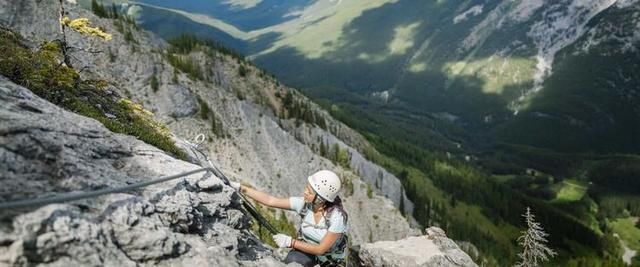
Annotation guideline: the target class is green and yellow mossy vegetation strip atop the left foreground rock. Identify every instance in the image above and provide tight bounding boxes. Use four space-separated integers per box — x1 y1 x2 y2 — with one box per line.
0 29 186 159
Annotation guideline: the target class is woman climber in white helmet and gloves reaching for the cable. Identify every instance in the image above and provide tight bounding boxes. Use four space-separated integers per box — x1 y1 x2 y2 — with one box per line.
231 170 348 267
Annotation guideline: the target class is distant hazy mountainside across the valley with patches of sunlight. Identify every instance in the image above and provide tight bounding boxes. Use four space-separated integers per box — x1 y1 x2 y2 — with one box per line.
109 0 640 155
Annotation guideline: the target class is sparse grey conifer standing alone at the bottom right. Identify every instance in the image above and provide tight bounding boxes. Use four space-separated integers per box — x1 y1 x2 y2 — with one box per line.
516 207 557 267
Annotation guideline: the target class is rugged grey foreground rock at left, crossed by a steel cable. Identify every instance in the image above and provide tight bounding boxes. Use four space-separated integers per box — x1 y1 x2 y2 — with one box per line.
0 77 282 266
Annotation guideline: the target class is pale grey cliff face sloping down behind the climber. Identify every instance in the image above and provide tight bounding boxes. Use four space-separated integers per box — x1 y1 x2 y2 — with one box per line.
0 0 419 244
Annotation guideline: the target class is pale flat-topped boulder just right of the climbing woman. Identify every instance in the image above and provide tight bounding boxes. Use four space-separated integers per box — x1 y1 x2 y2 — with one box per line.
351 227 478 267
